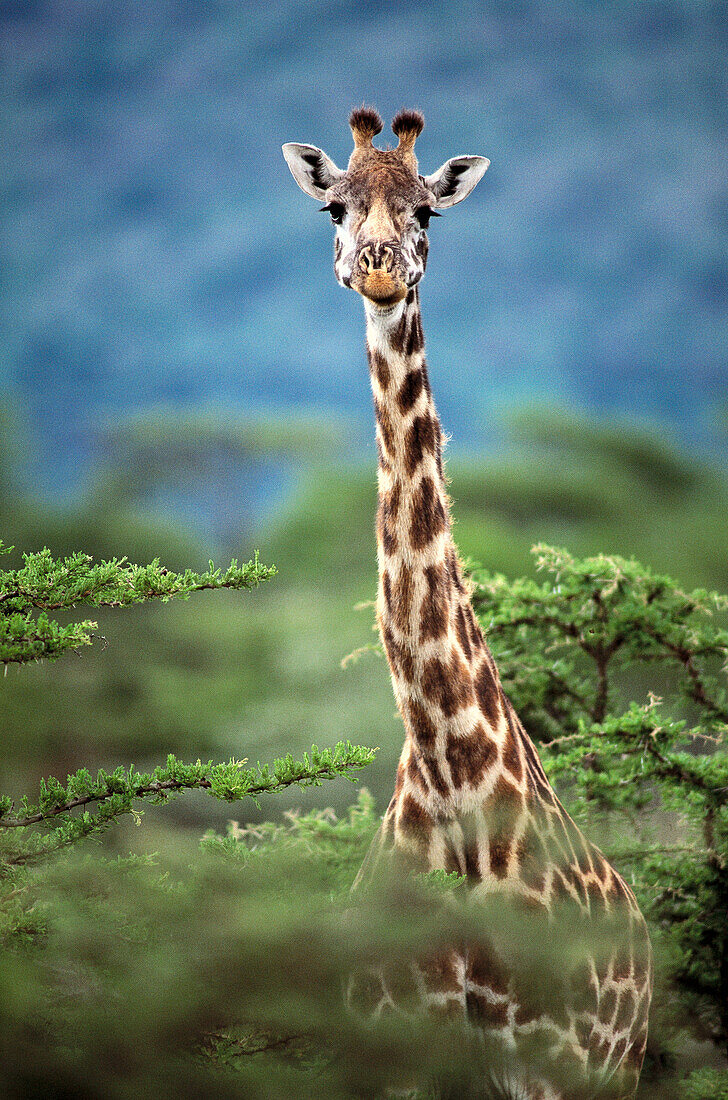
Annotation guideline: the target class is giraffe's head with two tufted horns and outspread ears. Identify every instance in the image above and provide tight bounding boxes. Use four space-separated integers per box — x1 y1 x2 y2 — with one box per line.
283 107 490 312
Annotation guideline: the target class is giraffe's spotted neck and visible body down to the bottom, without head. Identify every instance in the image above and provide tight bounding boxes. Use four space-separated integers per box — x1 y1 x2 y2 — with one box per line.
354 292 651 1098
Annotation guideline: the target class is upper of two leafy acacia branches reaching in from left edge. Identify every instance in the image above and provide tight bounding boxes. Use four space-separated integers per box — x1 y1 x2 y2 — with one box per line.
0 542 276 666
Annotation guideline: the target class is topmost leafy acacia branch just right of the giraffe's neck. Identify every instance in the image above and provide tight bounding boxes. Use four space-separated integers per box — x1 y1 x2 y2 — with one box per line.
473 545 728 740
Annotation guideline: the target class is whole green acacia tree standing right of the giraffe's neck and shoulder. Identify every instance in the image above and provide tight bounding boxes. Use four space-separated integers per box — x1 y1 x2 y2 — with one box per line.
474 546 728 1060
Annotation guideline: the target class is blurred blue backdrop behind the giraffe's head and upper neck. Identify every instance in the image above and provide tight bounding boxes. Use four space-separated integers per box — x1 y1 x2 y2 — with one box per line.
0 0 728 523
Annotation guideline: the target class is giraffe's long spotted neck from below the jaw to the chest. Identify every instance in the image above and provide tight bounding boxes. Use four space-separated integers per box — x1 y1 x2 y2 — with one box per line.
367 289 512 809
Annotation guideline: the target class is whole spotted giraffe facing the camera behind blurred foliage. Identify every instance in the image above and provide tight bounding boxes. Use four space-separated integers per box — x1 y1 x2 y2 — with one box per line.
283 108 651 1100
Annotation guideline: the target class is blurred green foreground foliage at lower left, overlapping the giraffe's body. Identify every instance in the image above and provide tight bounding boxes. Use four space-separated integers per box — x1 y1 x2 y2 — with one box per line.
0 793 615 1100
